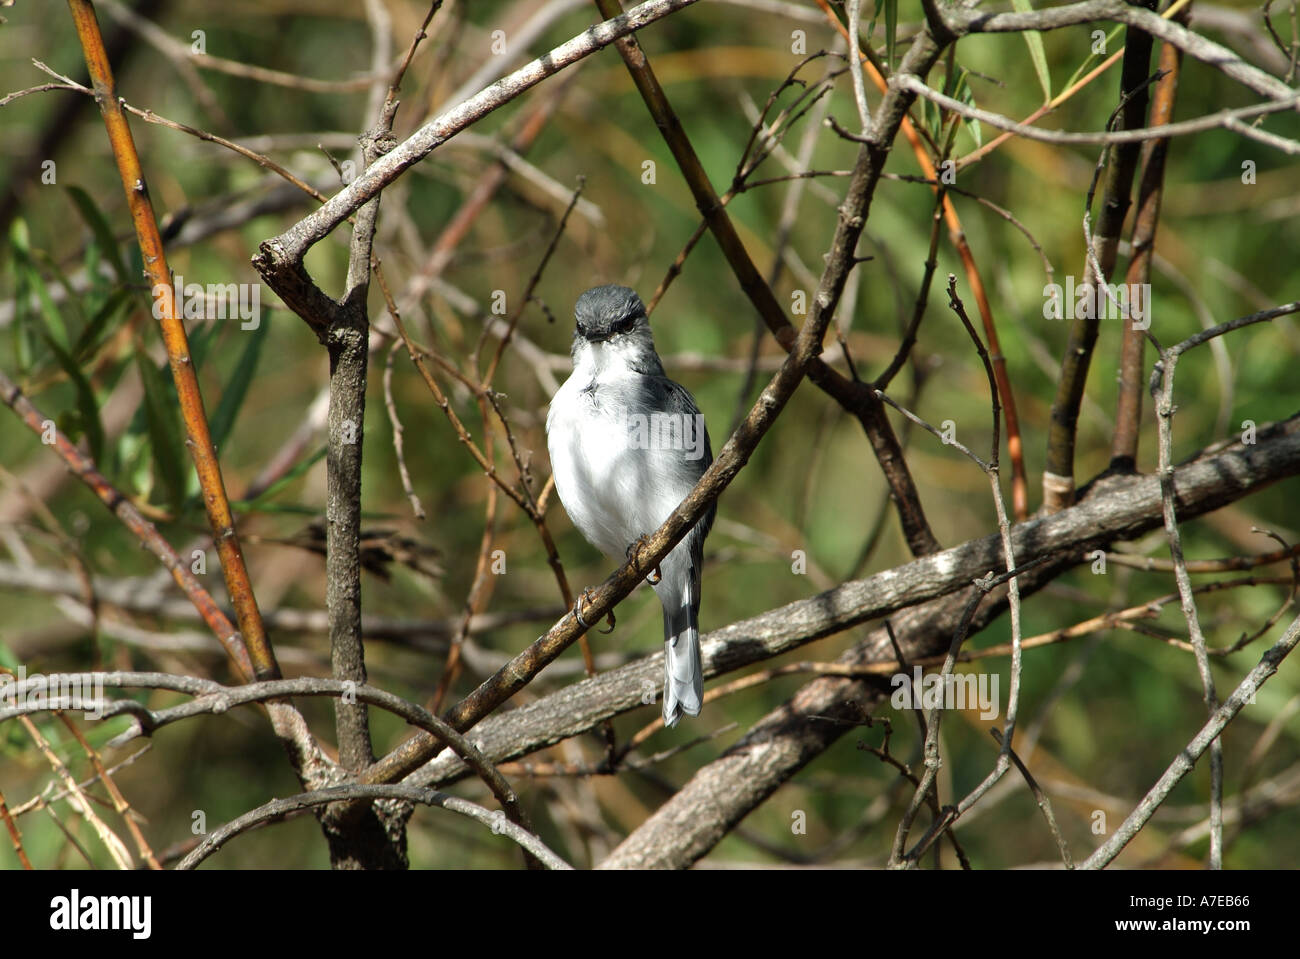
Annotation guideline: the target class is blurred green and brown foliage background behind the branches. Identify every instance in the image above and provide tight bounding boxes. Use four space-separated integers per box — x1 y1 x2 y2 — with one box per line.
0 0 1300 868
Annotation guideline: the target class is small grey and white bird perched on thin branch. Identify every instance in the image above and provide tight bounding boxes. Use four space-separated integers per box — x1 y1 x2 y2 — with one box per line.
546 285 716 726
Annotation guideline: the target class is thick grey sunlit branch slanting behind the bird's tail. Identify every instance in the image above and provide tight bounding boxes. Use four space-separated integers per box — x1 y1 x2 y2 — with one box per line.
415 416 1300 790
